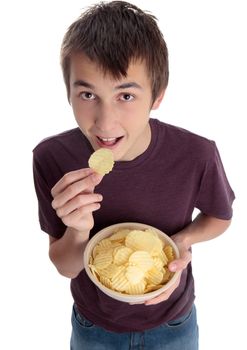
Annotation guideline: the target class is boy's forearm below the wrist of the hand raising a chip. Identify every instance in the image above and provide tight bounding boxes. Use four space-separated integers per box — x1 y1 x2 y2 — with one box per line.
49 228 89 278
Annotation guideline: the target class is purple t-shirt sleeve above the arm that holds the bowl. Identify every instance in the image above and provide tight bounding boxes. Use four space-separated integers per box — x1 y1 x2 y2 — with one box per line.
195 142 235 220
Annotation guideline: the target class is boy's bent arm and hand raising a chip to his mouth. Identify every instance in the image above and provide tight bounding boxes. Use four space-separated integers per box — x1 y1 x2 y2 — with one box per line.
49 169 103 278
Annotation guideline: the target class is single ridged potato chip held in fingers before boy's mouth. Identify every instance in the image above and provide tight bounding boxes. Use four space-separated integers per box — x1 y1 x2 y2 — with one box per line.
88 148 114 175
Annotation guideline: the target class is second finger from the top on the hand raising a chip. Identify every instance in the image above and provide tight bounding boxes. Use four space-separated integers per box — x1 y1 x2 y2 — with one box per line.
52 173 103 210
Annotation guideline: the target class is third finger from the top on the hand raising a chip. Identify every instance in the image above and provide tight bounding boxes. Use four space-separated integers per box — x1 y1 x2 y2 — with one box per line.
56 193 103 217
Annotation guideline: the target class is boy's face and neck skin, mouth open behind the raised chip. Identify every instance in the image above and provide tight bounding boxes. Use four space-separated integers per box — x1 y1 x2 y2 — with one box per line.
70 54 163 161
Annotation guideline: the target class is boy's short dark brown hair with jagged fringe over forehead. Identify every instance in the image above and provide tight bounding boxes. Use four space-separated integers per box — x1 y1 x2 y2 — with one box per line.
61 1 169 101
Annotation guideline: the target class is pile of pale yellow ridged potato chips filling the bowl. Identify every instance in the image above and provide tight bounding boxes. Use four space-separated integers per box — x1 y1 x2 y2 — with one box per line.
89 229 175 295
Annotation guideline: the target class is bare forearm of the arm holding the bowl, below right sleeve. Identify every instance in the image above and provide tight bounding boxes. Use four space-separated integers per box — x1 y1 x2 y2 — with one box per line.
173 213 231 248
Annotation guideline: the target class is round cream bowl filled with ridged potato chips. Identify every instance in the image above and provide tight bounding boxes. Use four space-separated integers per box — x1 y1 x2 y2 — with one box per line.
84 222 179 303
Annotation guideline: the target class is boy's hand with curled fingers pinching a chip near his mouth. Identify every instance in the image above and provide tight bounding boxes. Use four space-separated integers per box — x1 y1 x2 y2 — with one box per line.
51 168 103 233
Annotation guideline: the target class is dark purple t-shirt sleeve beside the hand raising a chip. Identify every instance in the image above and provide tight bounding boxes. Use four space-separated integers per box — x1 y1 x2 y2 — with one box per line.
33 154 66 238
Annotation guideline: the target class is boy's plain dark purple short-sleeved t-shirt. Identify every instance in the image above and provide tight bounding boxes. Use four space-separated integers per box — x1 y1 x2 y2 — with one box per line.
33 119 234 332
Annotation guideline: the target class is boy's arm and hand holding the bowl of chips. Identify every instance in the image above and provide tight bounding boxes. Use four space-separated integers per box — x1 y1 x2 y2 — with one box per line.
145 213 231 305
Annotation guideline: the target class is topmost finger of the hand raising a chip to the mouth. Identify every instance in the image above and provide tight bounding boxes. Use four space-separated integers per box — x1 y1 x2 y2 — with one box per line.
51 168 94 198
